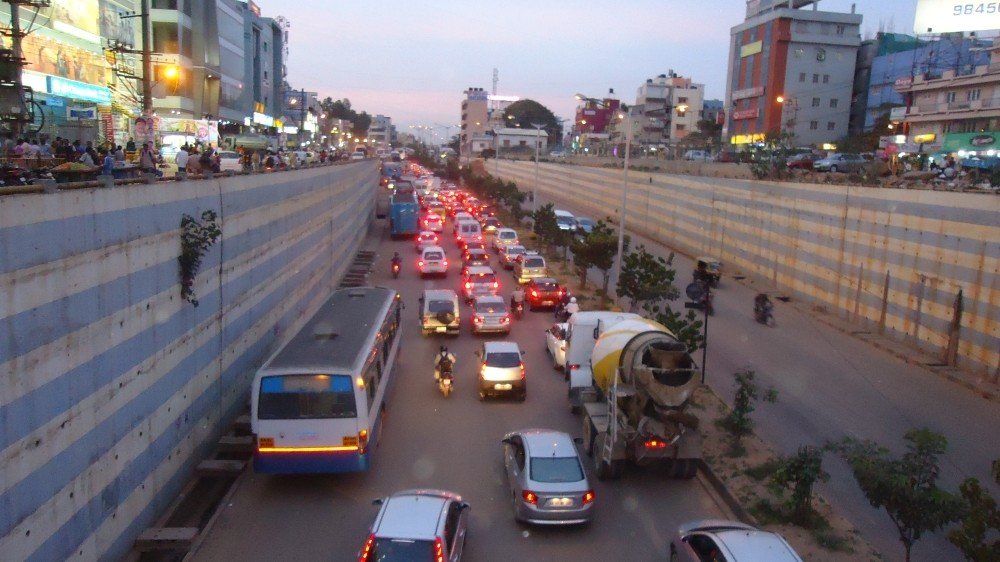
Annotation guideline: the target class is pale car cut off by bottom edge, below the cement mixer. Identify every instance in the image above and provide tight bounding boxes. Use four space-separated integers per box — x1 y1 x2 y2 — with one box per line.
670 519 802 562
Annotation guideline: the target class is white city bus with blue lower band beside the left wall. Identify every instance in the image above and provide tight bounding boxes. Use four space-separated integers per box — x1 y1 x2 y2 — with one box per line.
250 287 402 474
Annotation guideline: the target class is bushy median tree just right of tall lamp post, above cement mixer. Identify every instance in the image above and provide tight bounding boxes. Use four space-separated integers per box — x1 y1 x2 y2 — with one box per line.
616 244 680 312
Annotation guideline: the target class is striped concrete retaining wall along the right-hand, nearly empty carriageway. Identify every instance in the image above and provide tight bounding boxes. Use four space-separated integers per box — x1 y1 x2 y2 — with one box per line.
496 161 1000 380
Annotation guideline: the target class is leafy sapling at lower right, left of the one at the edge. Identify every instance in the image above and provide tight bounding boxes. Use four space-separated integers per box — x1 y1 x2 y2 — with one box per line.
838 428 964 562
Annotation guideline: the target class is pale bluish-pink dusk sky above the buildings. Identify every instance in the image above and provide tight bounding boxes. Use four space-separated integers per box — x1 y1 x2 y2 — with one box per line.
255 0 916 135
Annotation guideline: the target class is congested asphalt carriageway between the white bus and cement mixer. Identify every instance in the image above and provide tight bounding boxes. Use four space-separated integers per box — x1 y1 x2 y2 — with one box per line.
195 215 724 561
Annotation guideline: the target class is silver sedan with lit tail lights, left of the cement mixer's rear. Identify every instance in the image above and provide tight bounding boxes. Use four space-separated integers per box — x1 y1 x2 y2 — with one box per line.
501 429 594 525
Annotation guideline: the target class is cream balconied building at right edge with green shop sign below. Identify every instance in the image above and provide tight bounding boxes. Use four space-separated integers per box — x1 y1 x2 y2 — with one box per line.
898 39 1000 153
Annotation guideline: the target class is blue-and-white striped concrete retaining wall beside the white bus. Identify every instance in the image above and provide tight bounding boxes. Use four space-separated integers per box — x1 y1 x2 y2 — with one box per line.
0 162 377 561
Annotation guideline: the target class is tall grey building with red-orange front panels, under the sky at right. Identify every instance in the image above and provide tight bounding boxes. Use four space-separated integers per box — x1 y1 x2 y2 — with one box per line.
723 0 861 145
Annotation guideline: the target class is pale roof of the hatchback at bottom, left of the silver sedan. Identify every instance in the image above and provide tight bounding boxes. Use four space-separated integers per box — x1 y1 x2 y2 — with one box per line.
373 490 461 540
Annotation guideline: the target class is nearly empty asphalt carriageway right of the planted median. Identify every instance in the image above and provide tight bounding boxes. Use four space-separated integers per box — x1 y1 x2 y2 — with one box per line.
538 197 1000 562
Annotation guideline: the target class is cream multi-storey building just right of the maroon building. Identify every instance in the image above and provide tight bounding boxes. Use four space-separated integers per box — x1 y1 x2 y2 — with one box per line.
632 70 705 146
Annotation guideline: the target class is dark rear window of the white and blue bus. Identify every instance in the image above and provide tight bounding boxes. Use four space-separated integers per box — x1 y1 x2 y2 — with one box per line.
257 375 358 420
